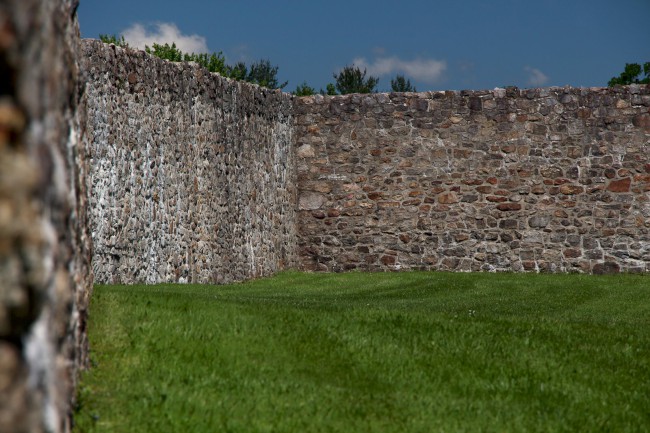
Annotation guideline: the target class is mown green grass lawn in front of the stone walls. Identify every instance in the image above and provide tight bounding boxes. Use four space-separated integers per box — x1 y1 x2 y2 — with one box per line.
75 272 650 433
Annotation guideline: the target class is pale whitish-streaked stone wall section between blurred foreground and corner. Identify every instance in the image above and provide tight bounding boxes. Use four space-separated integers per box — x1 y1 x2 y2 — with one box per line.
82 40 296 283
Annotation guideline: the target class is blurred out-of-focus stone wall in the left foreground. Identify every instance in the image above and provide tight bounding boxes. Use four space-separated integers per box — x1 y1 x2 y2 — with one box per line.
0 0 92 433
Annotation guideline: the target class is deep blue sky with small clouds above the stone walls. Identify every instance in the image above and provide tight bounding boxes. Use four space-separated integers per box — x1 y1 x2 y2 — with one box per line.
79 0 650 91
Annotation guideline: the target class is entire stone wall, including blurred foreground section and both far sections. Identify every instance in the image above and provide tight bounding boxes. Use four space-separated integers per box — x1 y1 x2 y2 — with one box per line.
0 0 650 433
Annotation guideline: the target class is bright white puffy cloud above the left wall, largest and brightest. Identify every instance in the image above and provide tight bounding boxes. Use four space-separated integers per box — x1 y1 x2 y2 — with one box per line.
122 23 209 53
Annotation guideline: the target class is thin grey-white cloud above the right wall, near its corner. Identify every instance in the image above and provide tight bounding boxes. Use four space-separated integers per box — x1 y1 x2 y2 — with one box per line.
353 56 447 84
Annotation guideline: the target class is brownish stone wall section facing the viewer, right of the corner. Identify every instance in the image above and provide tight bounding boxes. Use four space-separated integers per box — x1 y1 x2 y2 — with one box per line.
295 86 650 273
